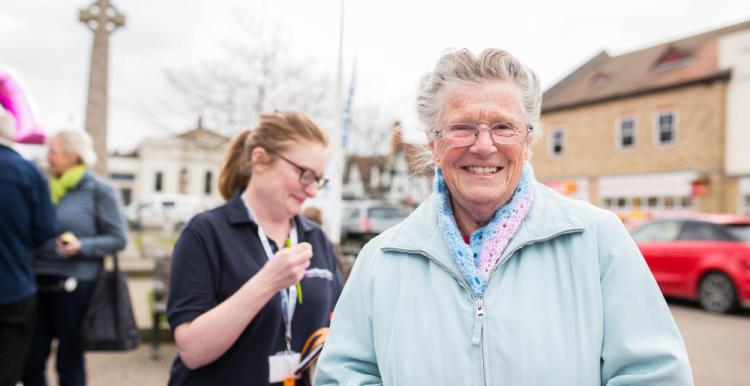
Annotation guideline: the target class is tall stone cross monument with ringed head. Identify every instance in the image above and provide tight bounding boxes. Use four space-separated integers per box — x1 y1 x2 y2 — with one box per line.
79 0 125 178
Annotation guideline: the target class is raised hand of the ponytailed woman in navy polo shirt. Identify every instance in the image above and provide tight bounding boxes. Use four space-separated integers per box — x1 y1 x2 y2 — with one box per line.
258 243 312 291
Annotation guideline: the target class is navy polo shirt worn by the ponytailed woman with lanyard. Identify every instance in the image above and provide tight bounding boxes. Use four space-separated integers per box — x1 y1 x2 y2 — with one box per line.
167 193 343 386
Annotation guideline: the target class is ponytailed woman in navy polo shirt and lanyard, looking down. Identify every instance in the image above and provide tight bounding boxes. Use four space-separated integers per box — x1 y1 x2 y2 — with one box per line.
167 112 342 385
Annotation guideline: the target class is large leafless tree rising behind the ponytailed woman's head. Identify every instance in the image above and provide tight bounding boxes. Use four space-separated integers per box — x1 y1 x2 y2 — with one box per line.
167 18 331 131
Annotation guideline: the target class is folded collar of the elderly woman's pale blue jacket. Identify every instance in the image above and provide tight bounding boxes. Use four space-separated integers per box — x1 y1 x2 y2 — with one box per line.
381 182 583 277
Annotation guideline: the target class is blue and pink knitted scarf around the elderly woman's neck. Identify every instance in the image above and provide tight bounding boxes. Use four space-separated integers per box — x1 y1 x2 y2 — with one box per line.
434 163 534 299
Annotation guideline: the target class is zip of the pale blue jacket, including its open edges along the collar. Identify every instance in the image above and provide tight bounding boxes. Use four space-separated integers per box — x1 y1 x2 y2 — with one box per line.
383 228 580 386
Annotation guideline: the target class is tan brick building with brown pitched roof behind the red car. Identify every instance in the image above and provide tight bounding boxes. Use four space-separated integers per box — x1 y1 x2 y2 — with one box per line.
533 22 750 222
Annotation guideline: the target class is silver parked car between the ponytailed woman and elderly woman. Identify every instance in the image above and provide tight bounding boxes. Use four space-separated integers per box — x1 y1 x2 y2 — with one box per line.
341 200 408 241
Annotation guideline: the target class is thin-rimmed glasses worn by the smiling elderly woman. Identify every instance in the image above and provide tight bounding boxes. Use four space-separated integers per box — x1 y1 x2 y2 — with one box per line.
432 121 534 147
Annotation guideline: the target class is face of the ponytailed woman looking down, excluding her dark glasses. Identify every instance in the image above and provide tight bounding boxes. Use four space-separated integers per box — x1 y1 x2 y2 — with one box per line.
251 141 329 218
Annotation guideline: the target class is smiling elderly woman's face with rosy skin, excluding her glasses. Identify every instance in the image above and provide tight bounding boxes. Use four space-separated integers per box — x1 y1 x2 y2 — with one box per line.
431 81 529 222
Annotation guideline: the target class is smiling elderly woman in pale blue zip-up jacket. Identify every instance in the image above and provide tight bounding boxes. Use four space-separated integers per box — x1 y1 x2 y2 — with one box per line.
315 49 692 386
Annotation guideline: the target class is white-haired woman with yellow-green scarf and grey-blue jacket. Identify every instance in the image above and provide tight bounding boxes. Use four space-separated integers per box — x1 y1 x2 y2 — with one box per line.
23 131 126 386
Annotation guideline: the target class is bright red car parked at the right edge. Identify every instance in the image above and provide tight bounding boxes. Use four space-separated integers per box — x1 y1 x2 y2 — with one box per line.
633 215 750 313
